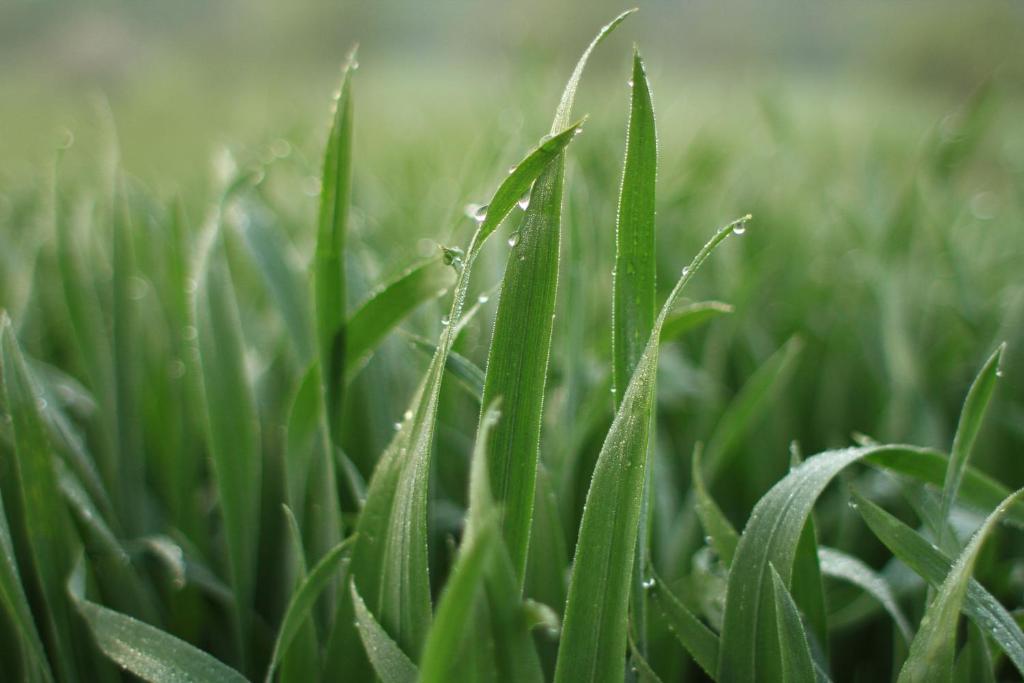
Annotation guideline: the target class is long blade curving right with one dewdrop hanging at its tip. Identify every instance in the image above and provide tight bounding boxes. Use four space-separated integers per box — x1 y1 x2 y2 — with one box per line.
555 217 749 682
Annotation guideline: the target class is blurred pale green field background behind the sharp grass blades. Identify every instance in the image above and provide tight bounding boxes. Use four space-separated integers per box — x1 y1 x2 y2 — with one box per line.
0 0 1024 680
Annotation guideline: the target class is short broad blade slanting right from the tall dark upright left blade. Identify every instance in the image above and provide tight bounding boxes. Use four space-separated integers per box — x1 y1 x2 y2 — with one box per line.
345 257 455 379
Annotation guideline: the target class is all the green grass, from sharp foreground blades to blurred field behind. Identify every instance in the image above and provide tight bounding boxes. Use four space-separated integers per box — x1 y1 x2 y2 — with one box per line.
0 6 1024 683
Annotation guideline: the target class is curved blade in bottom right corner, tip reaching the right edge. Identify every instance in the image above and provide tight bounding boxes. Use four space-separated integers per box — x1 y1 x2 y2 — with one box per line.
898 488 1024 683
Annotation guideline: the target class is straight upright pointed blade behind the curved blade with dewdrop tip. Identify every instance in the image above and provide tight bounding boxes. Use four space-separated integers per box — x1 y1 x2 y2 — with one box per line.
611 46 657 653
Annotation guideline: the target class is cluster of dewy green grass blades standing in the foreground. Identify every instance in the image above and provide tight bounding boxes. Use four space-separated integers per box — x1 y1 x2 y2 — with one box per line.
0 12 1024 683
